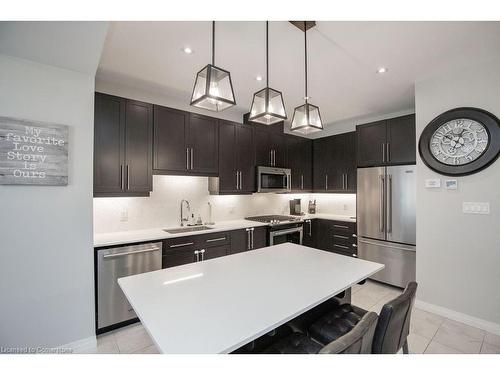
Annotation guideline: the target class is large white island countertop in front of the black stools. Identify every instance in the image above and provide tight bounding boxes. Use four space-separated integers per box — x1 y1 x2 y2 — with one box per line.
118 243 384 353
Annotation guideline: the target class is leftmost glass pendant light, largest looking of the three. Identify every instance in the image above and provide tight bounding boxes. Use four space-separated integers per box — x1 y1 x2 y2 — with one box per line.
191 21 236 112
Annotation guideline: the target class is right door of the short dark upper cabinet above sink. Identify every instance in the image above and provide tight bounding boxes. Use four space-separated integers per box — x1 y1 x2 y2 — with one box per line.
188 113 219 176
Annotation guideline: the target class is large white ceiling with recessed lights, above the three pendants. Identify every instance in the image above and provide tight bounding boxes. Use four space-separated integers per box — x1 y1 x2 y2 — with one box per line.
98 21 500 128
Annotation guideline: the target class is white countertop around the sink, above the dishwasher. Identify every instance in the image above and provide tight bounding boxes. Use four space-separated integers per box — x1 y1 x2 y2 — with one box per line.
94 219 267 247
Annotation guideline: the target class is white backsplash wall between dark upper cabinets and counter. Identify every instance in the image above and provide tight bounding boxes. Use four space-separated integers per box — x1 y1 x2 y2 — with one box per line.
94 176 356 233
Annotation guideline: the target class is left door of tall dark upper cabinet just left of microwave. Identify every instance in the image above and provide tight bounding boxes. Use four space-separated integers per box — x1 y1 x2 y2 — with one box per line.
219 121 238 193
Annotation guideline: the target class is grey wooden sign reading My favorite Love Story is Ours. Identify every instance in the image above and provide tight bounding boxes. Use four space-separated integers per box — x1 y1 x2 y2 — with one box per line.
0 117 68 185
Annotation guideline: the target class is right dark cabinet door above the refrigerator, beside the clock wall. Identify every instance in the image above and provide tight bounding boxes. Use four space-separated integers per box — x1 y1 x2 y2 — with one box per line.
387 115 416 164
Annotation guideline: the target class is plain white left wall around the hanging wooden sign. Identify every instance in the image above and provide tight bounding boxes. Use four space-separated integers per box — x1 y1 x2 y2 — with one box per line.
0 55 94 347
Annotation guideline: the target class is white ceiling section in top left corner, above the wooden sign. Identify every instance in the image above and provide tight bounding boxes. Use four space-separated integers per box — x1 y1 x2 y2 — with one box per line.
0 21 108 75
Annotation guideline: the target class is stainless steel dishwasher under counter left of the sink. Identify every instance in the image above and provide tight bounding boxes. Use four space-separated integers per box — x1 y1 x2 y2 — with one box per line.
97 242 162 330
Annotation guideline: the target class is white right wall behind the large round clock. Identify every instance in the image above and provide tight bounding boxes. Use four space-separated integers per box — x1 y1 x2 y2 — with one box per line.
415 60 500 330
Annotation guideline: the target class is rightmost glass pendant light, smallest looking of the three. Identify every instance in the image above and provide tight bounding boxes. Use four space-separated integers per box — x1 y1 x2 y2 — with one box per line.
290 21 323 134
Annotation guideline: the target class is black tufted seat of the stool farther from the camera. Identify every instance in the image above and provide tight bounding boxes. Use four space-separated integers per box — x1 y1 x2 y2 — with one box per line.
308 304 367 345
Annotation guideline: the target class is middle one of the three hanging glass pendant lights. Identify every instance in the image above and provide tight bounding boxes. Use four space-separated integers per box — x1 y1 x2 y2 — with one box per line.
248 21 287 125
